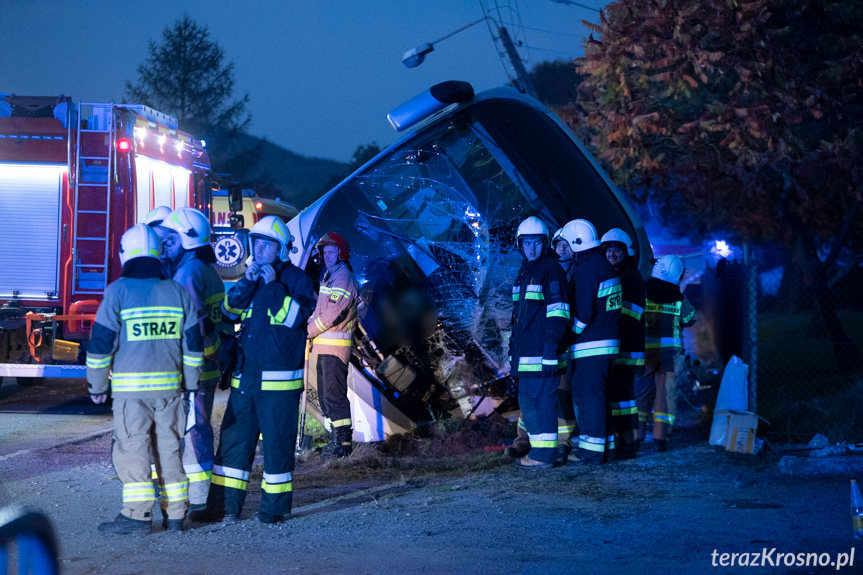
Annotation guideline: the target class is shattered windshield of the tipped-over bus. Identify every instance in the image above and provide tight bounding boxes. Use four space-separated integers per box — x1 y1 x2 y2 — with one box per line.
312 95 632 418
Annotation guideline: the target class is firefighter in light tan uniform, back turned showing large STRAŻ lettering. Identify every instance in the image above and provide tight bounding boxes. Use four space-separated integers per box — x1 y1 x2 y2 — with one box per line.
87 224 203 534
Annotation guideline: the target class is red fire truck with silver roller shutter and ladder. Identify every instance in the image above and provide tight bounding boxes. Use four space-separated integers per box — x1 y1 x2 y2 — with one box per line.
0 93 212 385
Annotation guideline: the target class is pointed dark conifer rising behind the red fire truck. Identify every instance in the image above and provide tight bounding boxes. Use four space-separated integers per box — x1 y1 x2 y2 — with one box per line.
126 15 251 138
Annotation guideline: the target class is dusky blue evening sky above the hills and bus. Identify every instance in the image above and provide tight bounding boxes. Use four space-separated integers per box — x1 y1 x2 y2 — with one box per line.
0 0 606 161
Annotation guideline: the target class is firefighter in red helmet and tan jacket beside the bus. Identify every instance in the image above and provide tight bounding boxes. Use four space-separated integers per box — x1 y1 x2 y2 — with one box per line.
308 232 359 457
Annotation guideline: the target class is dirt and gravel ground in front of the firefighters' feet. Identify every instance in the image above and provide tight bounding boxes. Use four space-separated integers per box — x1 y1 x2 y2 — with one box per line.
0 380 863 575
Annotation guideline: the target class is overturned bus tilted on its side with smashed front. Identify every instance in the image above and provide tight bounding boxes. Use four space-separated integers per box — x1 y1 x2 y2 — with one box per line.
288 82 653 441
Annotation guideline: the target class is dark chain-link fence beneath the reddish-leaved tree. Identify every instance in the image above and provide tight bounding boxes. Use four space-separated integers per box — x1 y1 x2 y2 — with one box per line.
701 247 863 443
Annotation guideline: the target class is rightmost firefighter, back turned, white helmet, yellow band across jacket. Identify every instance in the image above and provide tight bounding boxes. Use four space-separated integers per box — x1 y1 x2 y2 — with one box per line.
635 255 695 451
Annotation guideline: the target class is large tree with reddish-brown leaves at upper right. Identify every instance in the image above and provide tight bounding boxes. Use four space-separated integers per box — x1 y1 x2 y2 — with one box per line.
562 0 863 365
